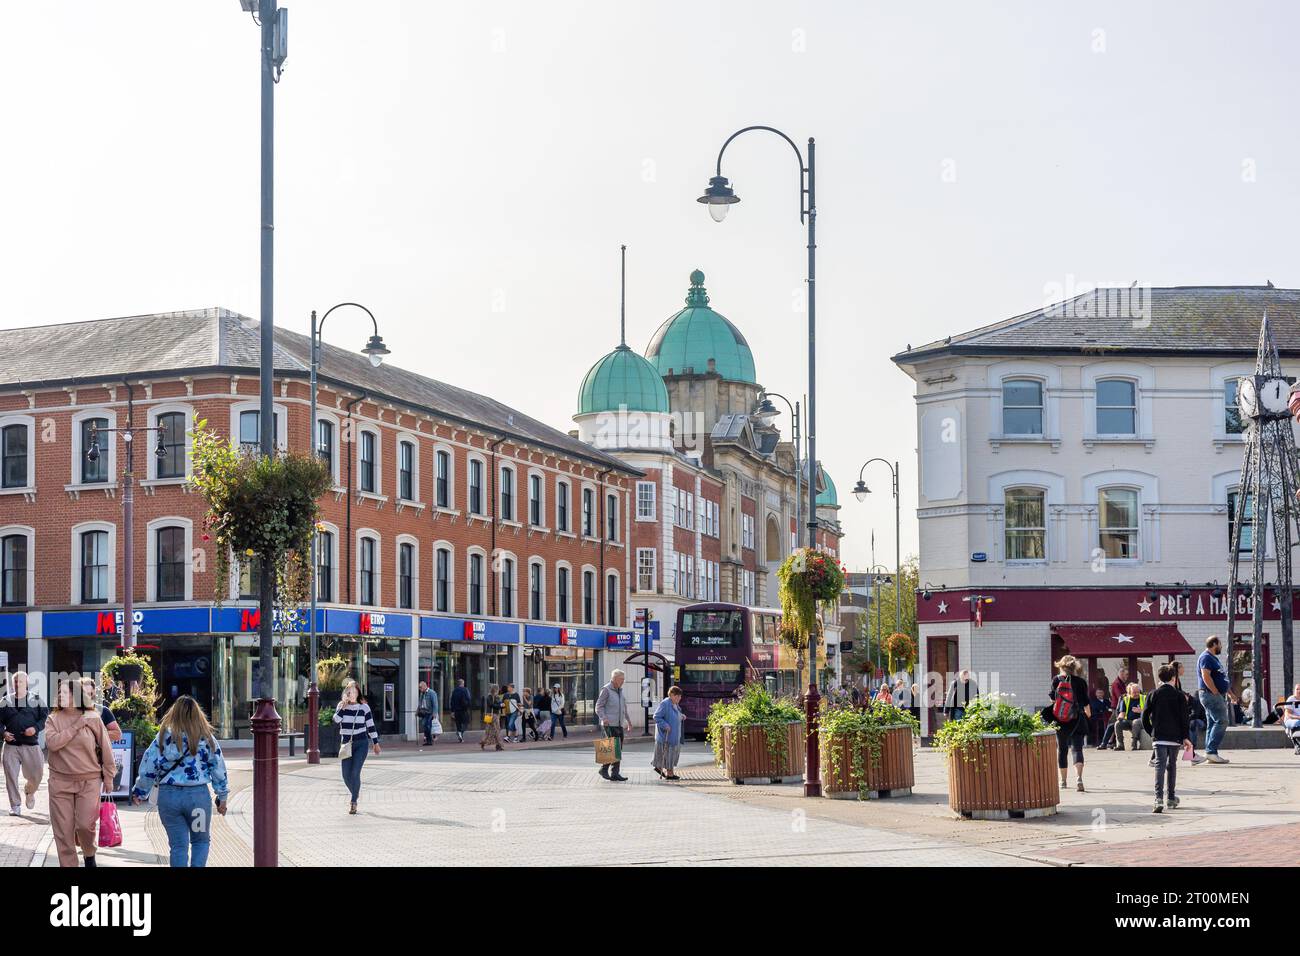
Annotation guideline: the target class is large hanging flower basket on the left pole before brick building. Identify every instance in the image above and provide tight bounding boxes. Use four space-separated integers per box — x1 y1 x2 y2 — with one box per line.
190 420 333 609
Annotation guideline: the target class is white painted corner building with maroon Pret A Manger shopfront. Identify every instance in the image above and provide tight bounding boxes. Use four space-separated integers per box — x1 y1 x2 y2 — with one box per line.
893 286 1300 732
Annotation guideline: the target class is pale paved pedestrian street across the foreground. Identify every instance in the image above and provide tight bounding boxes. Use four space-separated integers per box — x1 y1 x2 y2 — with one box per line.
10 743 1300 866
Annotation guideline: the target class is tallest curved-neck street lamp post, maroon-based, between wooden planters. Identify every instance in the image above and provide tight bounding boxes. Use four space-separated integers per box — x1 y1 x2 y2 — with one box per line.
697 126 822 796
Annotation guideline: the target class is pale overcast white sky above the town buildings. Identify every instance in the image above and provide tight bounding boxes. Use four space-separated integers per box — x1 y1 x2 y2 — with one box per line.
0 0 1300 568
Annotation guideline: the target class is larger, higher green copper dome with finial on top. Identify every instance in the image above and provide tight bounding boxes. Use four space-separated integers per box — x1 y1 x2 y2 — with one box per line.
646 269 758 384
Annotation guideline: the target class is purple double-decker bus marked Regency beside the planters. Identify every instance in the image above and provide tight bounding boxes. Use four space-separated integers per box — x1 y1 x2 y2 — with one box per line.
676 604 798 740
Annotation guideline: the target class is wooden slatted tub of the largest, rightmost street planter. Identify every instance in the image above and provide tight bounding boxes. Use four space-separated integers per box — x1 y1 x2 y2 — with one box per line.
948 730 1061 819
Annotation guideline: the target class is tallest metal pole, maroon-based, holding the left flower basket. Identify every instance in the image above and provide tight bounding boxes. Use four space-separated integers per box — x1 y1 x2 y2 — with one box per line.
251 0 281 866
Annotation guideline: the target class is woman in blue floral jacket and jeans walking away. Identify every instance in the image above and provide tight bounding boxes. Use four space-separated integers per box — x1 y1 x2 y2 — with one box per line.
131 695 230 866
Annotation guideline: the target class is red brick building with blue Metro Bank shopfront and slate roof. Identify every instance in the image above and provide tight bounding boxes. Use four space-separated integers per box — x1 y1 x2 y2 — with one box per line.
0 308 642 737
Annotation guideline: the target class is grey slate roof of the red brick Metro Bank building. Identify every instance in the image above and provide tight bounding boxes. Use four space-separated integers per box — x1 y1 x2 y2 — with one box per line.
0 308 641 475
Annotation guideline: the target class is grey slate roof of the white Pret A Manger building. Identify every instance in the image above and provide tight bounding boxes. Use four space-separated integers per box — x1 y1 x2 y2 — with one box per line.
893 285 1300 365
